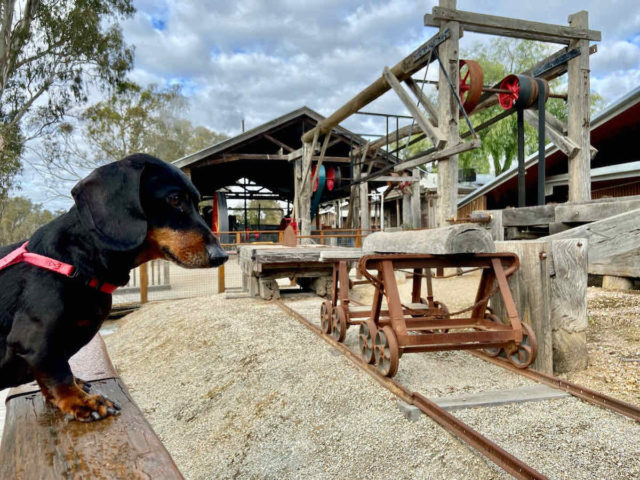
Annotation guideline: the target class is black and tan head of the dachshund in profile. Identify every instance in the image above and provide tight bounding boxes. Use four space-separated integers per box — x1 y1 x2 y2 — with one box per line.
71 154 228 268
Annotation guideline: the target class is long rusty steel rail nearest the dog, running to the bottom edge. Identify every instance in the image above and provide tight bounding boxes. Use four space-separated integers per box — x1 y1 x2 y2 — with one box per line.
275 300 548 480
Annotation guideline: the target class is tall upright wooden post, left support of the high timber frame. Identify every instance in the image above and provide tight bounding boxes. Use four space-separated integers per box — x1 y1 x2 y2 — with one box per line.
436 0 460 227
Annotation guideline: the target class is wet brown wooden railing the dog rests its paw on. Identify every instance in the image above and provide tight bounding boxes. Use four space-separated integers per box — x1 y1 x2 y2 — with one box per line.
0 335 183 480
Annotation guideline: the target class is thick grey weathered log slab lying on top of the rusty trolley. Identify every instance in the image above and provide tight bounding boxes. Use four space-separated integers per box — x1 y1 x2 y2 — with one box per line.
362 223 495 255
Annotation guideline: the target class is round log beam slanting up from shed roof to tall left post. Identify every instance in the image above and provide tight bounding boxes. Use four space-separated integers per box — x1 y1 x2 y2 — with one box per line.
302 31 449 143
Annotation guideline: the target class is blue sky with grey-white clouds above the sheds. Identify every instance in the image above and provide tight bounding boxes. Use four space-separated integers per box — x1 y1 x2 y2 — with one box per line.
17 0 640 206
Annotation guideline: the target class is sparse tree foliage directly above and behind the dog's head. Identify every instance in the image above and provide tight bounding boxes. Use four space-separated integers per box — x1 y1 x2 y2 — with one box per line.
39 83 226 196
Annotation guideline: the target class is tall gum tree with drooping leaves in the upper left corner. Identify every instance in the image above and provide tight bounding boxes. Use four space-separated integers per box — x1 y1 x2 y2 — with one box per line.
0 0 134 198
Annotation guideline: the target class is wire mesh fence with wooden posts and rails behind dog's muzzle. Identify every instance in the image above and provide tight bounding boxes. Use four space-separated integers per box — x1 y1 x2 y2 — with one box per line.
113 228 373 306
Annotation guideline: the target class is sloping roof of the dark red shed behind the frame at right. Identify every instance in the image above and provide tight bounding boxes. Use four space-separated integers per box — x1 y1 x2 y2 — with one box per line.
458 87 640 208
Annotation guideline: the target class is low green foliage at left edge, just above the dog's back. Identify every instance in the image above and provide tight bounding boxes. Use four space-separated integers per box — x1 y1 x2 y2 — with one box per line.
0 197 60 245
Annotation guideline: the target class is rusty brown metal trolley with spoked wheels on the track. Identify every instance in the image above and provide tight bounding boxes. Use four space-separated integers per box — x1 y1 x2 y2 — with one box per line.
321 253 537 377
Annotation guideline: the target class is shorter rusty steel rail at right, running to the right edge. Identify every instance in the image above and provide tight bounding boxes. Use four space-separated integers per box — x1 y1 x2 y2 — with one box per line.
469 351 640 422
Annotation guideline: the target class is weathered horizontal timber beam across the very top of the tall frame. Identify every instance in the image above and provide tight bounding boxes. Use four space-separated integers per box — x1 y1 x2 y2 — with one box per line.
424 7 602 45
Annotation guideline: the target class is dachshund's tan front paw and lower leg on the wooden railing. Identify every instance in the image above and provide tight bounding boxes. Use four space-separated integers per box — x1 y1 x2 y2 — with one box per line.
34 362 120 422
